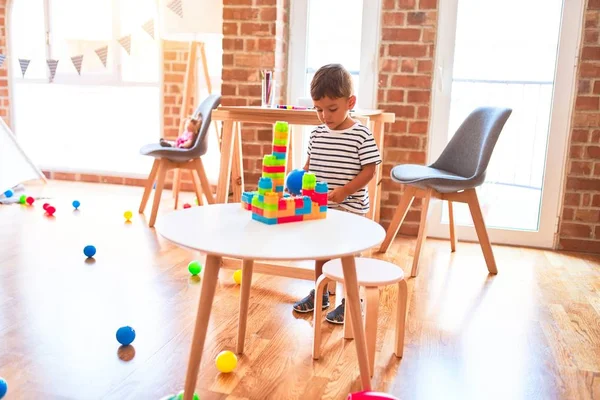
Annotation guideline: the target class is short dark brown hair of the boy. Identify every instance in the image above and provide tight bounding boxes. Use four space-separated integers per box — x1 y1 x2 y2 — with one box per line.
310 64 353 100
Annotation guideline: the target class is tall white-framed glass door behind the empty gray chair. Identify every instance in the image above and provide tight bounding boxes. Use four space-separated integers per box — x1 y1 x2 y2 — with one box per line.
427 0 583 247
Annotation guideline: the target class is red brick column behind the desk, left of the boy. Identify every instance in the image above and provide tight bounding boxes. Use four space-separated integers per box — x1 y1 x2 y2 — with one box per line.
221 0 289 188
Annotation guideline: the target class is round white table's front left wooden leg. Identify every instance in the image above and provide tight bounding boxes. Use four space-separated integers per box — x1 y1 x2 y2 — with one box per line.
183 254 221 400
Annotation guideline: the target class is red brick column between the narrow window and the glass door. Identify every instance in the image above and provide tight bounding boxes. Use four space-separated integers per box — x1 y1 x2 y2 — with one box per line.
378 0 437 235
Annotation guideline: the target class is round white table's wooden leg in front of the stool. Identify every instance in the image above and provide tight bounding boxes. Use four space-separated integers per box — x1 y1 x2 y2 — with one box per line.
342 256 371 390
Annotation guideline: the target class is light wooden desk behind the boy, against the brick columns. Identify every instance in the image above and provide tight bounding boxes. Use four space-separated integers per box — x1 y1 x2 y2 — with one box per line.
211 106 396 222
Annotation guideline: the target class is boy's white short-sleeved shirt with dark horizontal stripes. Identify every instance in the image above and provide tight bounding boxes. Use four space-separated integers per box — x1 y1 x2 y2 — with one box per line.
308 123 381 214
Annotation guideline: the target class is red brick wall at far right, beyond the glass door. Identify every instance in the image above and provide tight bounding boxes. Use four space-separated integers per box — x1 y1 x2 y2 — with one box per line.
559 0 600 253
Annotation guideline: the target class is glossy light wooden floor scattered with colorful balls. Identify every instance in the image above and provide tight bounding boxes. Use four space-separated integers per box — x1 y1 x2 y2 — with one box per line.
0 182 600 400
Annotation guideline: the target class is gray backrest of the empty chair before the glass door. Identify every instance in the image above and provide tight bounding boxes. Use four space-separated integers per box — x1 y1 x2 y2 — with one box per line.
431 107 512 179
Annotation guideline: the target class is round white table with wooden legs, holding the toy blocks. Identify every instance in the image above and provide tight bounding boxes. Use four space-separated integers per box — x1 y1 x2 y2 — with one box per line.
156 203 385 400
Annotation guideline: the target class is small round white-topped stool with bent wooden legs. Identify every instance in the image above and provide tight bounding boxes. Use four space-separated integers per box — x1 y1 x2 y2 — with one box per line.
313 257 407 376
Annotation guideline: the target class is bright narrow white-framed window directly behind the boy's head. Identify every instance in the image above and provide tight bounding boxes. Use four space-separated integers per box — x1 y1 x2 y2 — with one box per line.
288 0 381 165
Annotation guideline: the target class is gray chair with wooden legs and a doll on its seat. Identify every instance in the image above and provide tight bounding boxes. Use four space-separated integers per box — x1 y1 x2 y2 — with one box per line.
139 94 221 227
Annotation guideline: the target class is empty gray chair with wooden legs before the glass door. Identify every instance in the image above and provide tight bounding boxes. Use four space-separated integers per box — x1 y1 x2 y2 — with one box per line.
379 107 512 277
